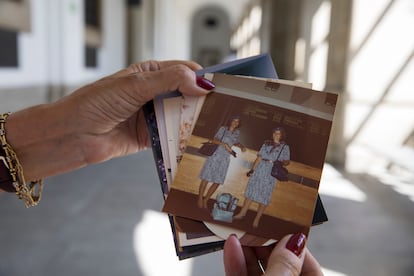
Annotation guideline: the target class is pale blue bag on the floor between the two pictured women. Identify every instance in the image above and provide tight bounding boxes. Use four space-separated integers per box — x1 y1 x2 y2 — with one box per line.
211 193 239 222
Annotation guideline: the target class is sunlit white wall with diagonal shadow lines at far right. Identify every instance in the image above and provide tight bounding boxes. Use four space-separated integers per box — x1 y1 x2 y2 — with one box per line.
344 0 414 168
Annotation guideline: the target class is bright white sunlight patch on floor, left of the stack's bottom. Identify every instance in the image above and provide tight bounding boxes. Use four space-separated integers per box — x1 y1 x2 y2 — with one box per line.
133 210 192 276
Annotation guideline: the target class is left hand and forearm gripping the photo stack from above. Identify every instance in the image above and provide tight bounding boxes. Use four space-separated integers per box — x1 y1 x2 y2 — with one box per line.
6 61 214 180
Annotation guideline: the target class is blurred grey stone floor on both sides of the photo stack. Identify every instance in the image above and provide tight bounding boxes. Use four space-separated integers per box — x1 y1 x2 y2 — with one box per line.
0 151 414 276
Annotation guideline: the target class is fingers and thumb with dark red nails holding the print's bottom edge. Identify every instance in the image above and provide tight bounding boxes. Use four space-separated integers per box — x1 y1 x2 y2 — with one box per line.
223 235 323 276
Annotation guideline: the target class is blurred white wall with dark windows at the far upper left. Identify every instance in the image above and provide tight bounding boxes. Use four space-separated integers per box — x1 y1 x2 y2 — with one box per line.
0 0 126 88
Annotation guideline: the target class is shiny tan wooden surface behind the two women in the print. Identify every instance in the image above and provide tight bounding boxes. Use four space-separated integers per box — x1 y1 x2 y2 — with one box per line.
172 141 320 225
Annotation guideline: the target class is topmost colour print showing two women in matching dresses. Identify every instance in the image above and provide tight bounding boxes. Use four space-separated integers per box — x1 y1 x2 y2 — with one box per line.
163 74 337 242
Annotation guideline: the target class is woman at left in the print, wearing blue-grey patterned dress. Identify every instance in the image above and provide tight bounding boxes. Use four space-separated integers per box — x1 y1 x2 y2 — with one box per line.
197 116 246 208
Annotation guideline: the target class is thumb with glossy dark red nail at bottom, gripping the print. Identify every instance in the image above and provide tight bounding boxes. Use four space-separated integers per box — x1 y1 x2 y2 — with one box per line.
266 233 306 275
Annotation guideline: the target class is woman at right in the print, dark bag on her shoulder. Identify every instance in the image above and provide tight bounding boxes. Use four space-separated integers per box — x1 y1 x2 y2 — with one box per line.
234 127 290 227
